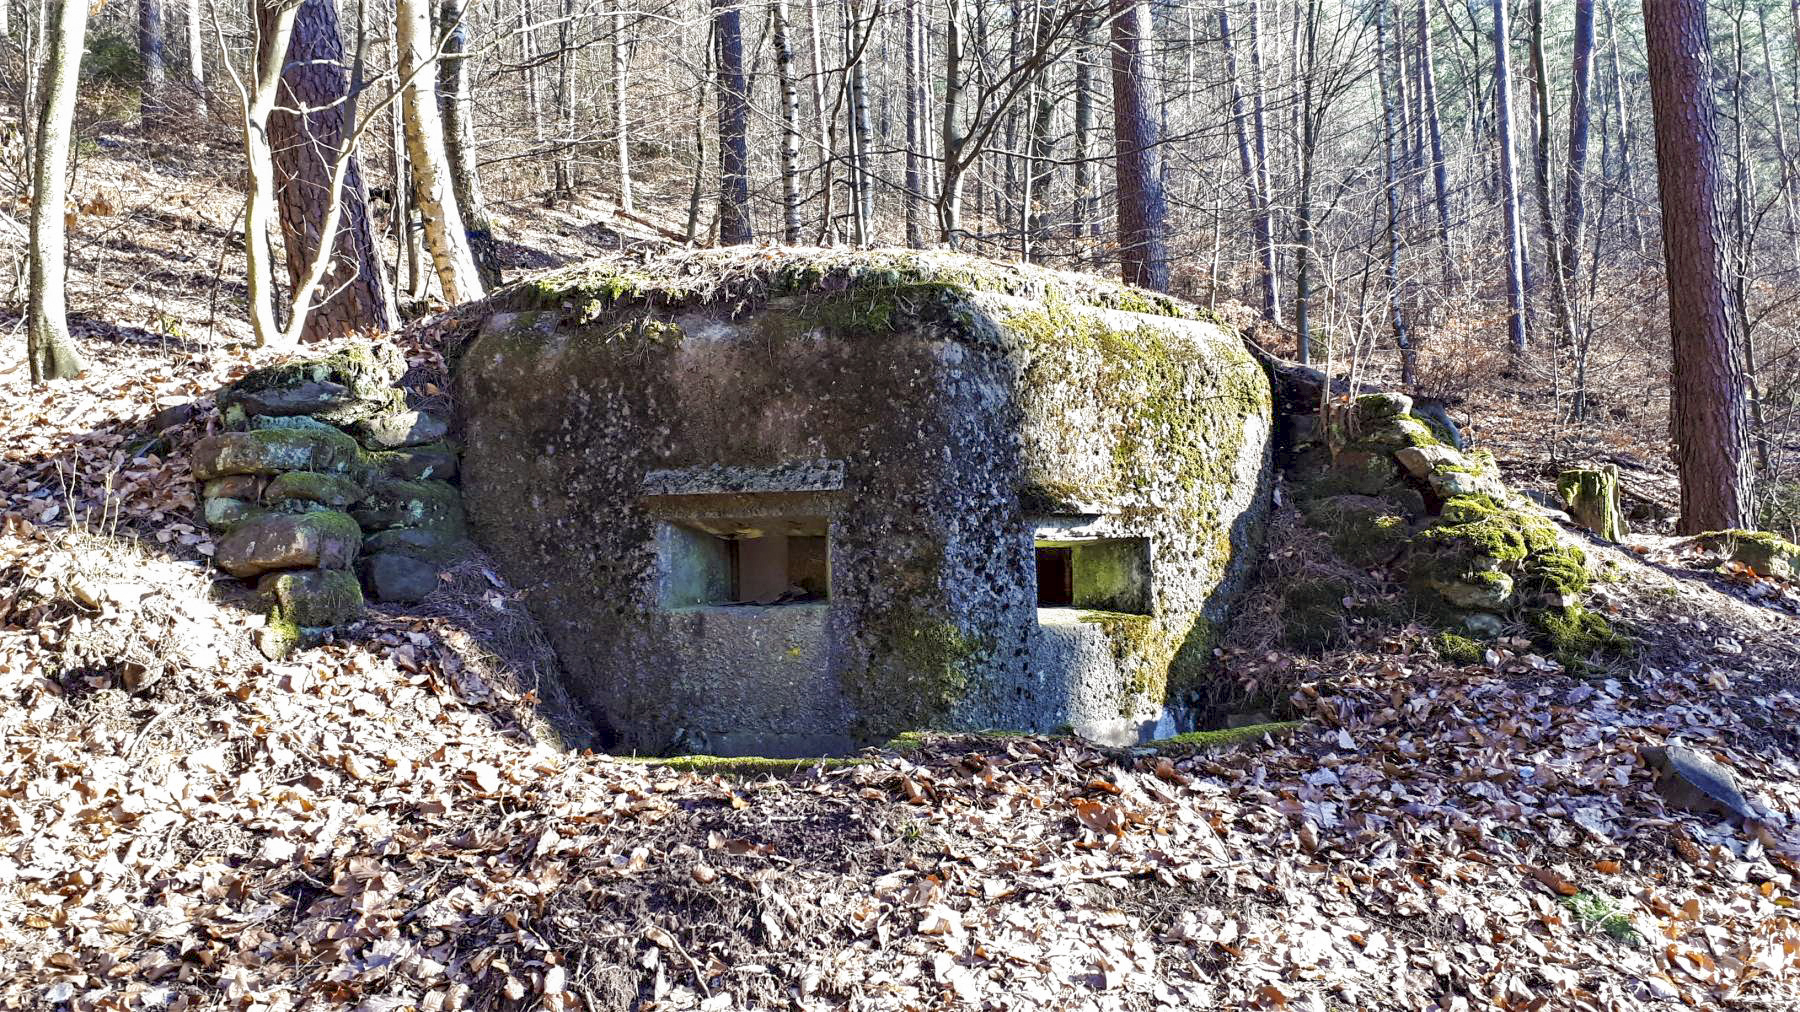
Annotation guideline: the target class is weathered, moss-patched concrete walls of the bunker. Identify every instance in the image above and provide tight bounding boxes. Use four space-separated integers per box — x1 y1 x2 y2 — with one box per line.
450 250 1271 754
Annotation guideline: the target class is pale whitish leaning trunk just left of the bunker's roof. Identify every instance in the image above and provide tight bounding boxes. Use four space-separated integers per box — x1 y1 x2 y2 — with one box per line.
394 0 482 306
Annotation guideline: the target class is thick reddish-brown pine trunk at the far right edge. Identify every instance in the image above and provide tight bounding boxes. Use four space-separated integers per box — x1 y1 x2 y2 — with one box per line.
1643 0 1755 535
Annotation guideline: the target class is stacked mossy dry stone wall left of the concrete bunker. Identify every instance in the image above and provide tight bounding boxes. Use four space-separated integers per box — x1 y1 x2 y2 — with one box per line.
191 344 466 657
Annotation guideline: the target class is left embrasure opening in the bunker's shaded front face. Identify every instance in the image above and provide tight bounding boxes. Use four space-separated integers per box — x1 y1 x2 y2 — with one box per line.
661 517 832 609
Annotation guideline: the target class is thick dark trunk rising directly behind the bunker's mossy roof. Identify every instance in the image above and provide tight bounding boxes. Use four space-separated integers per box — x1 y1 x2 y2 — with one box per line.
1112 0 1168 292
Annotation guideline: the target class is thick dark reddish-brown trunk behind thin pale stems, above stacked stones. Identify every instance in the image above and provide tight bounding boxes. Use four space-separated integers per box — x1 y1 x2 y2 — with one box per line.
257 0 394 340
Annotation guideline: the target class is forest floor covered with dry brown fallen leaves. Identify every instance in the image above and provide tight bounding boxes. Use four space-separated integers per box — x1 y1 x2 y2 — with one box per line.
0 135 1800 1010
